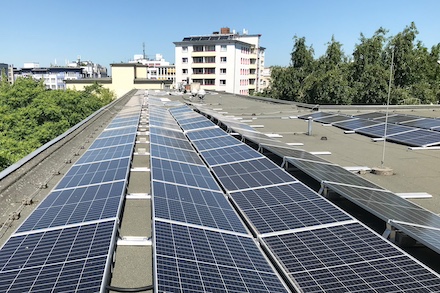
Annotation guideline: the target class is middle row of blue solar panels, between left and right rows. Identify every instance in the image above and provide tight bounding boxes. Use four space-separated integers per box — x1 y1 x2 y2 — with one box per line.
149 97 287 292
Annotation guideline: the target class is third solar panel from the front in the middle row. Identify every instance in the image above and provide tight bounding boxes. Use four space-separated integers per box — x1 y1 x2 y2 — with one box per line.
151 158 220 190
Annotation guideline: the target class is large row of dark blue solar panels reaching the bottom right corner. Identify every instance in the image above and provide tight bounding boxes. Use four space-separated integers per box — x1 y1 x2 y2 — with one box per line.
177 103 440 292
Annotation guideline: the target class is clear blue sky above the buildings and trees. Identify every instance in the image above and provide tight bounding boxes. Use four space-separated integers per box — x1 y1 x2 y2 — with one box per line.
0 0 440 67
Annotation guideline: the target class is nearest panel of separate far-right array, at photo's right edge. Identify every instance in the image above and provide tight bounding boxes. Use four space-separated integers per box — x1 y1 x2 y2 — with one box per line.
387 129 440 147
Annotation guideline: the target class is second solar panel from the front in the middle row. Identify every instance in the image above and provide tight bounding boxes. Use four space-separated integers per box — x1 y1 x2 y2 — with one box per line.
153 181 247 234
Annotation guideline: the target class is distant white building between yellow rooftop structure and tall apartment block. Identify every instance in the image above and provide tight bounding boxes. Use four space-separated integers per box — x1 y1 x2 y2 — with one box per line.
129 54 176 84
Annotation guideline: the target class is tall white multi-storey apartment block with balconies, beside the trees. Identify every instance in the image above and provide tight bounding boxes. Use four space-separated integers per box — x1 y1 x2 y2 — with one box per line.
174 27 265 95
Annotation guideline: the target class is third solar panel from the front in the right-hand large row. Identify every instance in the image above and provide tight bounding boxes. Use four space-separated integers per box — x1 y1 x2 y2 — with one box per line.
212 158 296 191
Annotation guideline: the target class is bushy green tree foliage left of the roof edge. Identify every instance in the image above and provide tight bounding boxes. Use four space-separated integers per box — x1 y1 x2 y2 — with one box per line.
0 77 115 171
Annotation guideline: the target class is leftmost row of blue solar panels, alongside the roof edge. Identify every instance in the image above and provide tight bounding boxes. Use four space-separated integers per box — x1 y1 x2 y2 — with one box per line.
0 90 141 292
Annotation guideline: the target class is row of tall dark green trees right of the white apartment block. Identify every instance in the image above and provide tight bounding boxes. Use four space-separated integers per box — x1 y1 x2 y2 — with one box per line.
264 23 440 104
